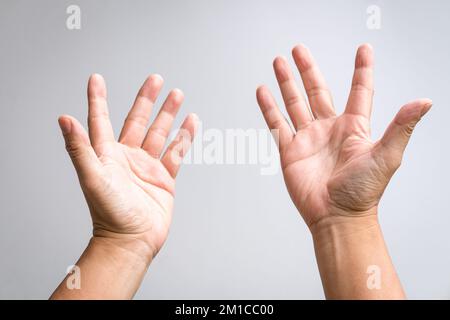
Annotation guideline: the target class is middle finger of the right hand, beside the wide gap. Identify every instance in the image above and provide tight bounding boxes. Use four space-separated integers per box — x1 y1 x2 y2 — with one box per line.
292 45 336 119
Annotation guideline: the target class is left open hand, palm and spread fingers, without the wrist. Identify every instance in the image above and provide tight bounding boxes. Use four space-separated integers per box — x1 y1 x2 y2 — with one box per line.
59 75 198 255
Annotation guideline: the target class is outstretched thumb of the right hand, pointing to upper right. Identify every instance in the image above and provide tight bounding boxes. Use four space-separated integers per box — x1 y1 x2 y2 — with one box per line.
380 99 432 155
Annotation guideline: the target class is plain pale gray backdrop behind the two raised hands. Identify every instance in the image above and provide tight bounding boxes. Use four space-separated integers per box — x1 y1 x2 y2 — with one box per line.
0 0 450 299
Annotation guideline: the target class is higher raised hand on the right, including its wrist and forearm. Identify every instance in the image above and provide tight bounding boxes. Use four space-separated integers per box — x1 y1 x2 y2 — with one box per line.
257 44 432 299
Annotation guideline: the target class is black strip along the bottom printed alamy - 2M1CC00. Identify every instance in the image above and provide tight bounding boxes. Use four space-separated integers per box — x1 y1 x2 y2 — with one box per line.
0 300 450 320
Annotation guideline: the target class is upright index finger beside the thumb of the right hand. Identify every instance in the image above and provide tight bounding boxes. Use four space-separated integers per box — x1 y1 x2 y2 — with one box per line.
345 44 373 119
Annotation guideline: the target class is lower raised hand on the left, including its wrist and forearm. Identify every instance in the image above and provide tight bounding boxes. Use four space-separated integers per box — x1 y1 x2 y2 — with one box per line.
51 74 199 299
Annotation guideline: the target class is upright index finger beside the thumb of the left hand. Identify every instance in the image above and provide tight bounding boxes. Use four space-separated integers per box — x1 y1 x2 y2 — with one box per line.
88 74 114 154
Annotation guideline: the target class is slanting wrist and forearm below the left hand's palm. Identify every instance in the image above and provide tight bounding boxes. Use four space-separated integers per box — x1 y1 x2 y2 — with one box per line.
50 237 151 299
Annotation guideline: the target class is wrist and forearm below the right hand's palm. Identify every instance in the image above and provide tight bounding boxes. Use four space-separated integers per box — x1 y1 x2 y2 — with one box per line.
311 214 405 299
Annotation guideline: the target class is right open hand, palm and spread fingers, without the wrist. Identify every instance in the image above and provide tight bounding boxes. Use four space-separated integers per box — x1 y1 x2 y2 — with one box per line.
257 45 431 226
